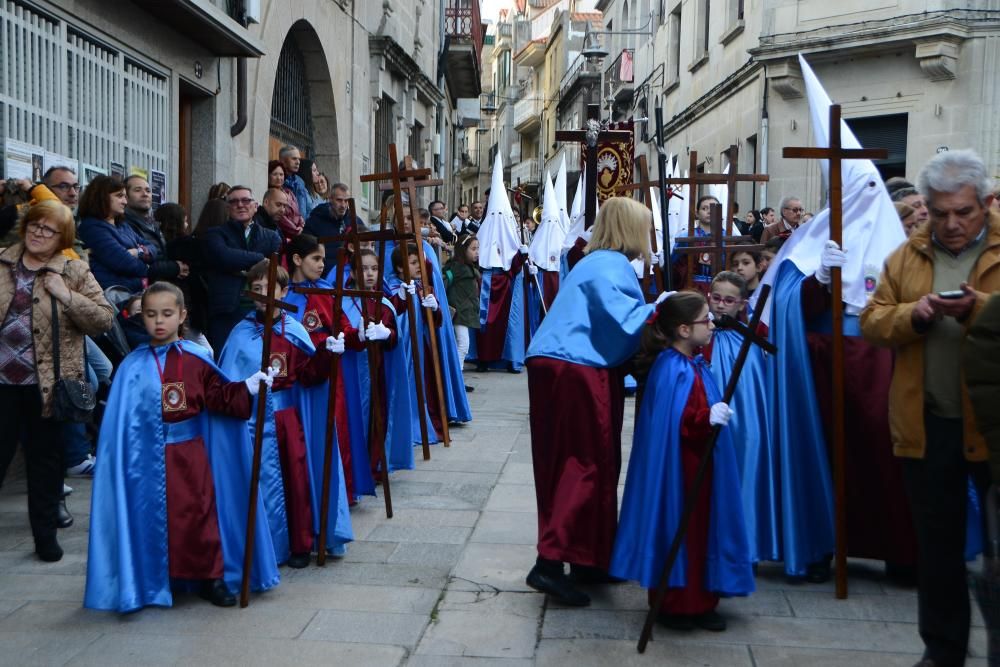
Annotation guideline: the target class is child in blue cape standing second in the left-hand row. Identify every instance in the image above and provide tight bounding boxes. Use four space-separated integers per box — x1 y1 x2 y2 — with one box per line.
220 260 353 568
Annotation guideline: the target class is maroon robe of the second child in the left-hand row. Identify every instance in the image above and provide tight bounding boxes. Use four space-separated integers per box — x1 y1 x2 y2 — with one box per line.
271 326 334 554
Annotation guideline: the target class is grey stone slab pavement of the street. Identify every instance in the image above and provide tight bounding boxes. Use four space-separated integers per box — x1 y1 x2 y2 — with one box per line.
0 373 986 667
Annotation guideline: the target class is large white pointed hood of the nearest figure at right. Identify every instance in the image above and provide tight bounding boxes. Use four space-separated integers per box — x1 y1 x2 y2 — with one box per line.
751 54 906 324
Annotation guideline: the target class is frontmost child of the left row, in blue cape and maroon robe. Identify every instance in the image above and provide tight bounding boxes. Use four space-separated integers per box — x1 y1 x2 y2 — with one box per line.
84 282 279 612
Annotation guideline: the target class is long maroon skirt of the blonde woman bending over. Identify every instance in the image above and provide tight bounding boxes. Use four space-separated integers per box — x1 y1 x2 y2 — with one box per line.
527 357 625 570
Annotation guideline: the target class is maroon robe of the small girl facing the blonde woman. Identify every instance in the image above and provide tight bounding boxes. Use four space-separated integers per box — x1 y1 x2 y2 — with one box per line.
649 374 719 614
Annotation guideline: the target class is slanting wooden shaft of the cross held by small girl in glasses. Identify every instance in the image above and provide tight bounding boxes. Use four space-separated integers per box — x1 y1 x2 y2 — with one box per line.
637 285 777 653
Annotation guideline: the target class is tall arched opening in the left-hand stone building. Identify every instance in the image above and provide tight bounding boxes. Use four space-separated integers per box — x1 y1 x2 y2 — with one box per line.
268 20 341 180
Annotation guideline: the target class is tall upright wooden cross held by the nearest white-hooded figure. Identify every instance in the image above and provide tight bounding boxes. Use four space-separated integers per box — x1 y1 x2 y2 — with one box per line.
781 104 889 600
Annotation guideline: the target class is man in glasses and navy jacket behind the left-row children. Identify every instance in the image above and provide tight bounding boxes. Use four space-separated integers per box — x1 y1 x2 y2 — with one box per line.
205 185 281 358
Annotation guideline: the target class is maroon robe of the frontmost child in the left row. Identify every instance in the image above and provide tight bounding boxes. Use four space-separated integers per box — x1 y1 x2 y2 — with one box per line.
162 348 251 579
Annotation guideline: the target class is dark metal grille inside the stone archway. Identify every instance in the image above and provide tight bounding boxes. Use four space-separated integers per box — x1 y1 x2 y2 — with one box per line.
271 39 314 155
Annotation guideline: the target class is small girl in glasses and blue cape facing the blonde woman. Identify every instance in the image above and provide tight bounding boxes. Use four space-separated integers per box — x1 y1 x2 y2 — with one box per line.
610 291 754 631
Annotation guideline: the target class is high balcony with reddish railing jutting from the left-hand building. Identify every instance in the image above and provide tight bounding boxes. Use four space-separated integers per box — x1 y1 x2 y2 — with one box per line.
444 0 483 99
